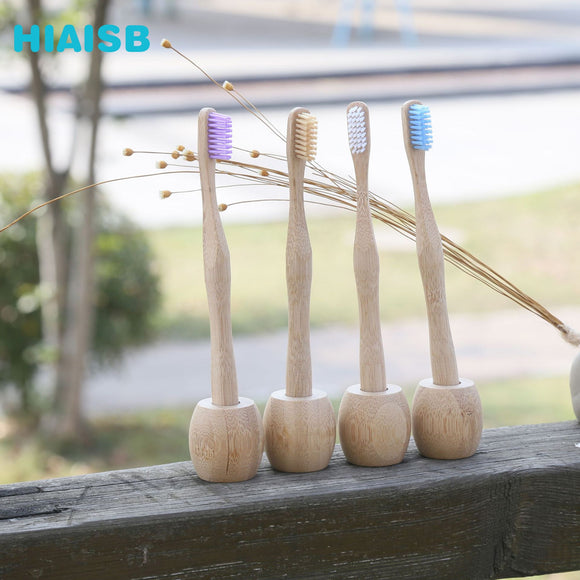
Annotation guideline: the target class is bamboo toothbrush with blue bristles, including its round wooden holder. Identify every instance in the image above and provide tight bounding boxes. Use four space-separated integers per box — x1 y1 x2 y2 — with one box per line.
402 101 482 459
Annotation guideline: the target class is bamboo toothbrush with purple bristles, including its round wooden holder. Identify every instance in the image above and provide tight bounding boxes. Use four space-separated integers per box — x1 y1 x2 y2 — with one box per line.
189 108 264 482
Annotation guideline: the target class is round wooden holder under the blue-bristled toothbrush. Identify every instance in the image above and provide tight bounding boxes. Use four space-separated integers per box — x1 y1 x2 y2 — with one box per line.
413 379 483 459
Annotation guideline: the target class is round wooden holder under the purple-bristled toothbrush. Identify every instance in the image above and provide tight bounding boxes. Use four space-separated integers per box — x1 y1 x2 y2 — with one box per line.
189 397 264 483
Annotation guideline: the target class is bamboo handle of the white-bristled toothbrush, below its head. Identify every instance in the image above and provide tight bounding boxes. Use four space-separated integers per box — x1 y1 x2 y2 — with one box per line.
353 155 387 392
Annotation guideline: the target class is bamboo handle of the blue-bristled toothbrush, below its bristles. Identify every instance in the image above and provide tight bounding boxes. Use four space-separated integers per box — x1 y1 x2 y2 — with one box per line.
404 131 459 386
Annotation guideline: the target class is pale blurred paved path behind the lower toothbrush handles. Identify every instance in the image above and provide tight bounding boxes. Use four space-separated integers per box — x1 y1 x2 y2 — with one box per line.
85 308 580 418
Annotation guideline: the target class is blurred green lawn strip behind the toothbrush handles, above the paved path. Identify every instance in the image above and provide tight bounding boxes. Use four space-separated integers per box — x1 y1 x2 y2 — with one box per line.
148 184 580 337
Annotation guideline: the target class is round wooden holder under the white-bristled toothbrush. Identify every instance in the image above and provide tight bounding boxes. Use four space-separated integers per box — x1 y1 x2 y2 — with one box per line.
338 385 411 467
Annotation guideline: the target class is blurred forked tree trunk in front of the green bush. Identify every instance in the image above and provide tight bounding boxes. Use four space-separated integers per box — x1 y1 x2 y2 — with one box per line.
4 0 121 437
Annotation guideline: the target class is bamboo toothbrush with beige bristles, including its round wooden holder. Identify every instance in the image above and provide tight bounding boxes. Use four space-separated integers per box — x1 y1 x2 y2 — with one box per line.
264 107 336 472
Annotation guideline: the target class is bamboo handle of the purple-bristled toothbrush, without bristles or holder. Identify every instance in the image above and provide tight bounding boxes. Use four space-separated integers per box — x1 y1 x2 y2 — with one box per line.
198 109 239 406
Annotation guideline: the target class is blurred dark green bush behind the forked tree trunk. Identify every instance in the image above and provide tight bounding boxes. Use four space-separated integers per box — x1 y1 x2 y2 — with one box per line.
0 174 160 430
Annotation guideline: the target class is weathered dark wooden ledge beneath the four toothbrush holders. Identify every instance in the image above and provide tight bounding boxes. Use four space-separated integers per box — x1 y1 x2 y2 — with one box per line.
0 422 580 580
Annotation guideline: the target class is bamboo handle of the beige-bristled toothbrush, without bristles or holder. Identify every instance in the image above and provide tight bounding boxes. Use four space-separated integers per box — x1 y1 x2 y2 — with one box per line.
286 108 312 397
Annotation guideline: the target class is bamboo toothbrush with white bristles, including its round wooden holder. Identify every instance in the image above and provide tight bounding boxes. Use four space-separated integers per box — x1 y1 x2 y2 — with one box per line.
338 102 411 466
